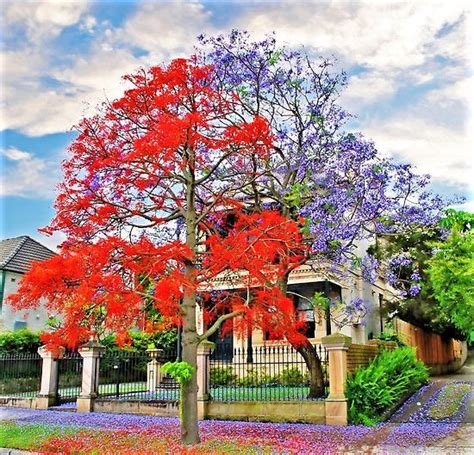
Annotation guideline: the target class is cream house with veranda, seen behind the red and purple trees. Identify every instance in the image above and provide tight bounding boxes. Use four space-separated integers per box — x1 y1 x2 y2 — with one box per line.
197 237 392 350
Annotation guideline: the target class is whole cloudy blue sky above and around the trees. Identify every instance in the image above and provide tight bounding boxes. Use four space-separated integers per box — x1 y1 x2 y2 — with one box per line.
0 1 474 247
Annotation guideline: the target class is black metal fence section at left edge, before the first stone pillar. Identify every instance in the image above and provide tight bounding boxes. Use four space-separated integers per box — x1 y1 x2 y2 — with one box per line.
0 353 43 398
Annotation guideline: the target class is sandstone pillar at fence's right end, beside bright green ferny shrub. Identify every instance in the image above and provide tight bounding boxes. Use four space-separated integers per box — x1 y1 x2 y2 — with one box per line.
321 333 352 425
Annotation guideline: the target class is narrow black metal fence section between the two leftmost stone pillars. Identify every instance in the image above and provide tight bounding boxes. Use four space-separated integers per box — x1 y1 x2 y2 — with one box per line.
56 352 83 403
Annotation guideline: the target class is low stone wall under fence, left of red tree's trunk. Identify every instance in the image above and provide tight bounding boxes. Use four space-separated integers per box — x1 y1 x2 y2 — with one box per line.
94 400 179 417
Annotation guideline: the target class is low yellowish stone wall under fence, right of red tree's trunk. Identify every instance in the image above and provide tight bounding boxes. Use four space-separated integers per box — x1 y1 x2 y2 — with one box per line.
207 400 326 424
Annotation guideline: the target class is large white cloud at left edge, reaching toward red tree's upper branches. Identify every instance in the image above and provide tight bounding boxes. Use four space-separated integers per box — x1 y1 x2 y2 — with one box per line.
0 49 140 136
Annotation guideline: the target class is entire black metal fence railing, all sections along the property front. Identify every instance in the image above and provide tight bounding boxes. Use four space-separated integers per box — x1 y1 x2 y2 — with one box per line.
0 345 328 403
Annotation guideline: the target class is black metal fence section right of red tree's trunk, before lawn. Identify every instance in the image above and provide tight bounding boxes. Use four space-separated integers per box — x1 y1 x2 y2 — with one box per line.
210 345 328 401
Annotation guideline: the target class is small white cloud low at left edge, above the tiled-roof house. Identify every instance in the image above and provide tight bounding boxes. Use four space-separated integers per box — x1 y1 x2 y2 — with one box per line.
0 148 60 199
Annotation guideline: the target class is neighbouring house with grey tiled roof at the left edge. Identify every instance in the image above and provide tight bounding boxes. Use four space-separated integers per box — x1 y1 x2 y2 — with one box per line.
0 235 55 332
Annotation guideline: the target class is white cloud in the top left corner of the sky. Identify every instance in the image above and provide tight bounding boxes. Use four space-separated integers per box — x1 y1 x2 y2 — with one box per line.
3 0 89 41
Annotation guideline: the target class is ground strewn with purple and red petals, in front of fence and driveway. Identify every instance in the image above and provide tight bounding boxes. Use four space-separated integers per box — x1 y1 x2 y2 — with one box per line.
0 383 470 454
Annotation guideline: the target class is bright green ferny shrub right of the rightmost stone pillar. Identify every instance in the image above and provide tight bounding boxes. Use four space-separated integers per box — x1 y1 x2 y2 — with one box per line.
347 348 428 425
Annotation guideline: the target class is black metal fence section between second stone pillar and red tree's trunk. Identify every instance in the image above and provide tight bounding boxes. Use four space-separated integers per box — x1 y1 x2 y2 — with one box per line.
98 350 179 401
